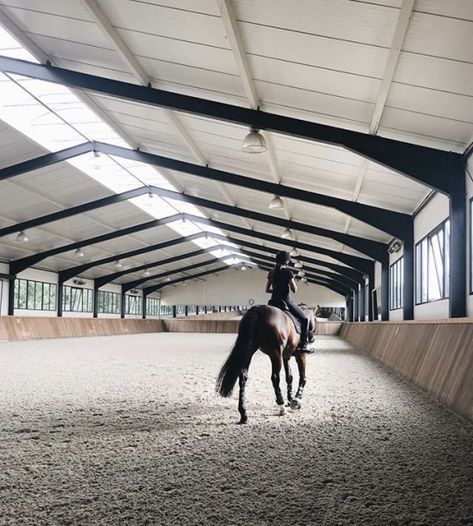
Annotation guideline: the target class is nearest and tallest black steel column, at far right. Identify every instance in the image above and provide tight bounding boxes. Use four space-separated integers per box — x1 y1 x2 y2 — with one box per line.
448 157 467 318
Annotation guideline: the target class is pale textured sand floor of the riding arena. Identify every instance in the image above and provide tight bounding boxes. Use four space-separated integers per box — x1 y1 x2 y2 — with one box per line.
0 334 473 526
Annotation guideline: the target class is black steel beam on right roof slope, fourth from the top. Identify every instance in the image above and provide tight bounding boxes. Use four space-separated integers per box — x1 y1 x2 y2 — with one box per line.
186 214 374 274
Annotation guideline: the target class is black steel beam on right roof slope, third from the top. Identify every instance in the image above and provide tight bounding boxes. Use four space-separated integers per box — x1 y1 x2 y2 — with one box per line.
145 186 388 261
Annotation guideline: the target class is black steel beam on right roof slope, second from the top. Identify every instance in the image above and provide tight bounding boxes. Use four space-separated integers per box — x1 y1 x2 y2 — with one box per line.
95 142 411 238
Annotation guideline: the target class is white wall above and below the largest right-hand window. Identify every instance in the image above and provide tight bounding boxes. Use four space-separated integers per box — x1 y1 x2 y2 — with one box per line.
414 194 449 320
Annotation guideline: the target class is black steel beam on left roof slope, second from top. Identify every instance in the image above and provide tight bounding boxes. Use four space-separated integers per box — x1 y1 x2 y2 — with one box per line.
0 186 149 237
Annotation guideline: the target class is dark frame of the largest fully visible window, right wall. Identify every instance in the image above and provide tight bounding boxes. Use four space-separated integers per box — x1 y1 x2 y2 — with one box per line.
414 221 451 305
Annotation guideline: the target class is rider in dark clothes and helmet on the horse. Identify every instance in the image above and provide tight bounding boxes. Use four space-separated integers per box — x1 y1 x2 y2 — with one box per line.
266 250 313 353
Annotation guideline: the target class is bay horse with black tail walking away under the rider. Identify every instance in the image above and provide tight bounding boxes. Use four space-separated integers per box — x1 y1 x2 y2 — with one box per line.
216 305 315 424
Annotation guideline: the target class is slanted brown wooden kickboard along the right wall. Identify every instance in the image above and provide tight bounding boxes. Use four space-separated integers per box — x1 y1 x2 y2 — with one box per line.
340 318 473 419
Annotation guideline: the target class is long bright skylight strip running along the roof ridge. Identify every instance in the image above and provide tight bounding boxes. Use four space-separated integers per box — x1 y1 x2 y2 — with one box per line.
0 27 245 272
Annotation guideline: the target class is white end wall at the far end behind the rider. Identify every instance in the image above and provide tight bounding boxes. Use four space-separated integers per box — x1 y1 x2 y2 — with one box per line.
161 270 345 307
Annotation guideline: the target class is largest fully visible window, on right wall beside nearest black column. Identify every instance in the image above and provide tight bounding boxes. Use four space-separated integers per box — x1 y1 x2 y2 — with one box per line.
416 219 450 305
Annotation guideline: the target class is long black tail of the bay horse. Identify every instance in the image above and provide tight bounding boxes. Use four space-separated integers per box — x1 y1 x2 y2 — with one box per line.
216 307 258 397
